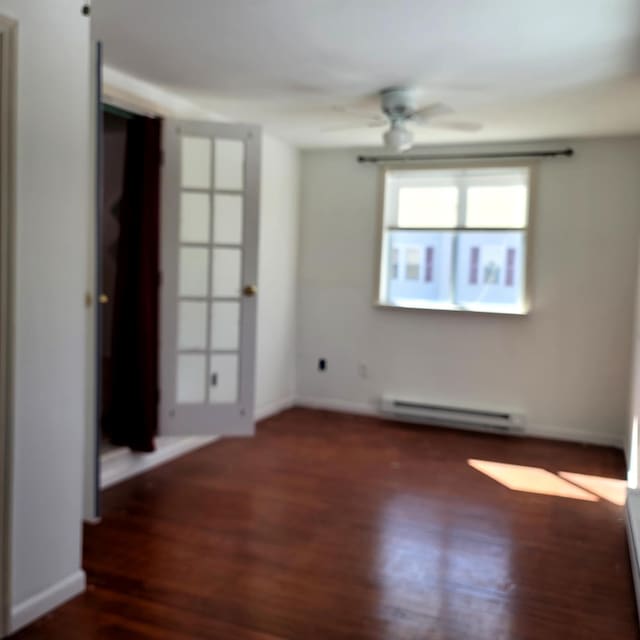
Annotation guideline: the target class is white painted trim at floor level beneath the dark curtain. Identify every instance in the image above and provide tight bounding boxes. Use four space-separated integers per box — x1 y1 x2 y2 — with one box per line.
100 436 218 489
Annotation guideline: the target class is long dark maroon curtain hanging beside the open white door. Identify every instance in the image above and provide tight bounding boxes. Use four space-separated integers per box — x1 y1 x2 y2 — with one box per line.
105 116 161 451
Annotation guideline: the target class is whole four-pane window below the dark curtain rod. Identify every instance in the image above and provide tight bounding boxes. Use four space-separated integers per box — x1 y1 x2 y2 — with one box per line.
379 166 531 314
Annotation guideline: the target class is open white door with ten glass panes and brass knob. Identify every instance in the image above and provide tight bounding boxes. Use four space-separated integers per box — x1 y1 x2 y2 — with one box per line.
159 120 260 435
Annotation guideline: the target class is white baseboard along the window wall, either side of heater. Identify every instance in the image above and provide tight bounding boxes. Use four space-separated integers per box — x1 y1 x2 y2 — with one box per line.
295 397 624 449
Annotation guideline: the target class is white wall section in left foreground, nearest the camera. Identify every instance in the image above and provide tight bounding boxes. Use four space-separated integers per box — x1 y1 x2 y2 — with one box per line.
0 0 91 627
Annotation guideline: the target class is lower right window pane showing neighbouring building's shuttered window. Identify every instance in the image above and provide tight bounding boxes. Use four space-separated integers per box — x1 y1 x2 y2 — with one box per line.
455 231 526 311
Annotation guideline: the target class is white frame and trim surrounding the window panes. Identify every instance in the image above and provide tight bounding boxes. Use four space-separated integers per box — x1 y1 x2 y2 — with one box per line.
374 160 537 316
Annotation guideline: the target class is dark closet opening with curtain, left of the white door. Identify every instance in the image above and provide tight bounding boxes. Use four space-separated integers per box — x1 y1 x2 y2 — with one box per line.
97 104 161 456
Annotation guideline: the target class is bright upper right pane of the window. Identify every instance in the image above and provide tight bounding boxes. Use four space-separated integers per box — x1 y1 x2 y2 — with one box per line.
466 184 527 228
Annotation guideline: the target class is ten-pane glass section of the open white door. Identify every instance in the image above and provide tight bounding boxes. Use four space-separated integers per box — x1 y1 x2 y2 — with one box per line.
171 131 246 412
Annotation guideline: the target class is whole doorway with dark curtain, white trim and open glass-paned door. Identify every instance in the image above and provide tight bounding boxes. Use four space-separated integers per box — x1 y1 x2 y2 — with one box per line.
85 74 261 522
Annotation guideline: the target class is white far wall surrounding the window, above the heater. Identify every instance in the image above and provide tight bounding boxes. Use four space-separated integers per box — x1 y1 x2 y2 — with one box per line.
297 139 640 446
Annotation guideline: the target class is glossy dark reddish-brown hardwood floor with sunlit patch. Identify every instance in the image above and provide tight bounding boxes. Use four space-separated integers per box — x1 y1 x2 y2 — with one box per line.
15 409 639 640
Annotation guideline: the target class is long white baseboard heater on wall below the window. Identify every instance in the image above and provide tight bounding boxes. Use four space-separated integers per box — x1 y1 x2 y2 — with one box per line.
381 396 525 433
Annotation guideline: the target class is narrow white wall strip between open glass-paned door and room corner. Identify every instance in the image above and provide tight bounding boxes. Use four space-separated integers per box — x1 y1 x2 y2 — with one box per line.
256 135 300 418
